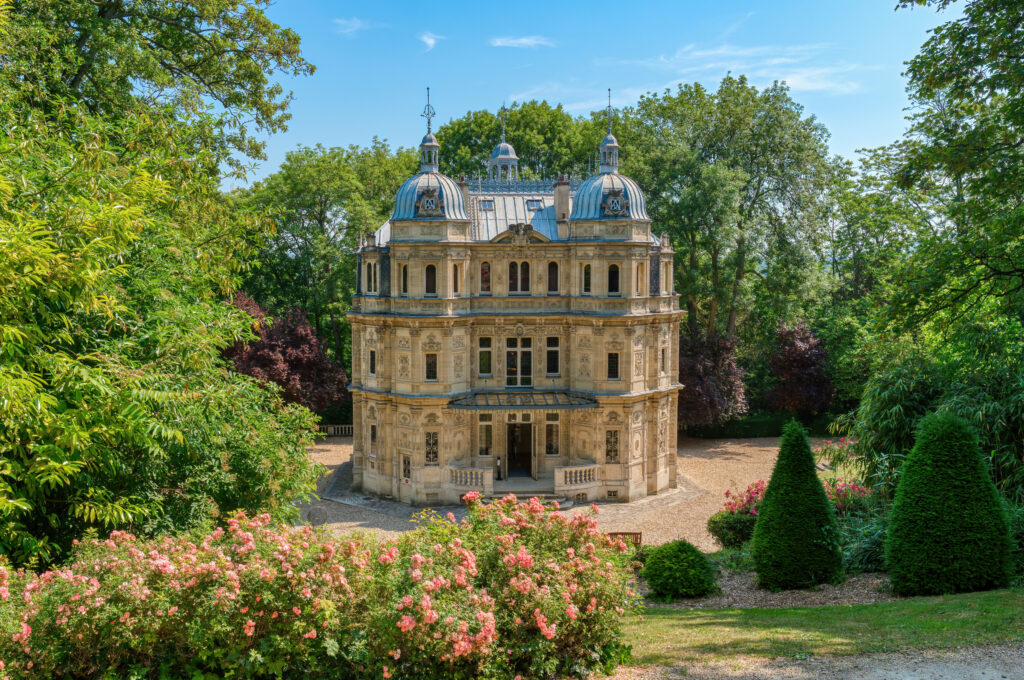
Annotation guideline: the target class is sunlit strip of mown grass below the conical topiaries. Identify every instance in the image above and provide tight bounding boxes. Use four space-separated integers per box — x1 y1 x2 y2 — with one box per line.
626 589 1024 666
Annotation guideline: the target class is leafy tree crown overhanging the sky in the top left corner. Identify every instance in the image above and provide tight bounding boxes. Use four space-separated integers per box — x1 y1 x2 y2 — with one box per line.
0 0 313 162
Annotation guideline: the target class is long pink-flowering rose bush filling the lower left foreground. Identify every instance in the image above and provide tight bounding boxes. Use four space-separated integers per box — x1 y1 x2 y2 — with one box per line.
0 497 637 680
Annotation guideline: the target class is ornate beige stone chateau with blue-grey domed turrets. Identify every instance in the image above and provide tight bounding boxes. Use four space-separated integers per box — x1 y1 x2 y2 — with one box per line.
349 96 682 505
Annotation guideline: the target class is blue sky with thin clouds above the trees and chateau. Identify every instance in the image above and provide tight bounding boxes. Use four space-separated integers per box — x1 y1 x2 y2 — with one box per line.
237 0 954 186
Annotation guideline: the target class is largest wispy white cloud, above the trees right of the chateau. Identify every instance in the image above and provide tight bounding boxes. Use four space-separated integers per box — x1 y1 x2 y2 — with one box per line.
620 43 872 94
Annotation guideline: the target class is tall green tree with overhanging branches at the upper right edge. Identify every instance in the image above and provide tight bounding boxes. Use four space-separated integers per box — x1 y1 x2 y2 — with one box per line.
889 0 1024 327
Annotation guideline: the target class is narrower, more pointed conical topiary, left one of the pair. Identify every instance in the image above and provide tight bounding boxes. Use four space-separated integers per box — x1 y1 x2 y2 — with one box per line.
753 420 843 590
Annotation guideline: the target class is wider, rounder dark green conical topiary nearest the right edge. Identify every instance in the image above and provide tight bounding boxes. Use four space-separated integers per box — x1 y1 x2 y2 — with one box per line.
886 413 1012 595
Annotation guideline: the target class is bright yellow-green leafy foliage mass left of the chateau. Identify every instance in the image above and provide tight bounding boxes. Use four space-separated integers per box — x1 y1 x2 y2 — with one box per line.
0 3 315 565
